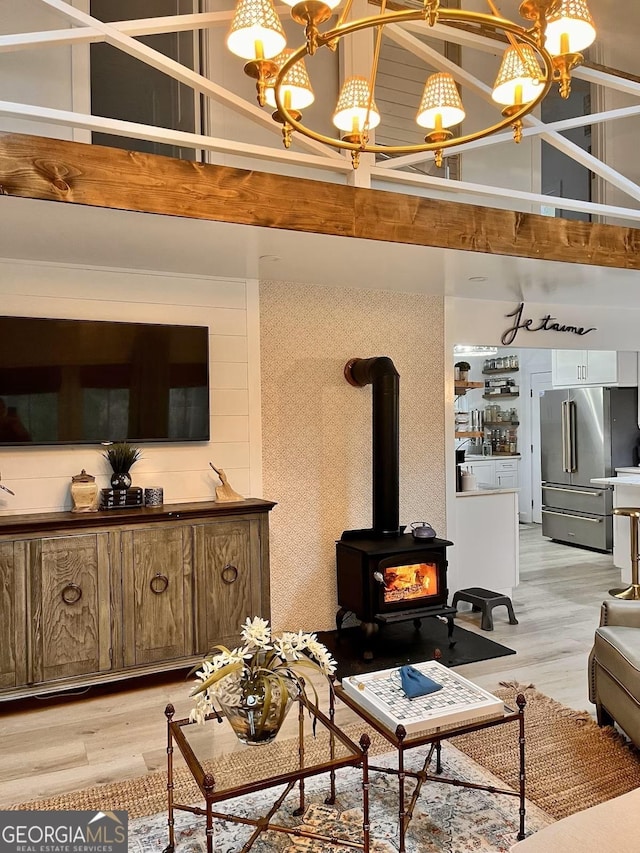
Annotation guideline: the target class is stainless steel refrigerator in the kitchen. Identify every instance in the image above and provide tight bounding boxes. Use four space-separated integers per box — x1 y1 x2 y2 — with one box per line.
540 388 640 551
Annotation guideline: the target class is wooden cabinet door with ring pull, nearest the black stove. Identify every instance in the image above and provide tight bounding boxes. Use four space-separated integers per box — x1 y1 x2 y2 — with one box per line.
194 521 266 653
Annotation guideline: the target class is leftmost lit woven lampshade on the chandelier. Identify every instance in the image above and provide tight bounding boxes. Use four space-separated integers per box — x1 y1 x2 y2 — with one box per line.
227 0 287 60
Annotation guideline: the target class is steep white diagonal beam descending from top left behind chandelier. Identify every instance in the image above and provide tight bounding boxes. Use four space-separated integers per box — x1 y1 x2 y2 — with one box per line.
35 0 344 160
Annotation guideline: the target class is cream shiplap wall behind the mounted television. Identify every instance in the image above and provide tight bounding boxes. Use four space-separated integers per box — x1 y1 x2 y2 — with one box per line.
0 260 261 515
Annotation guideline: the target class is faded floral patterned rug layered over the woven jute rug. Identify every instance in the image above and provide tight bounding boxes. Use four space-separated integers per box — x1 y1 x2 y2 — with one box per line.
129 743 553 853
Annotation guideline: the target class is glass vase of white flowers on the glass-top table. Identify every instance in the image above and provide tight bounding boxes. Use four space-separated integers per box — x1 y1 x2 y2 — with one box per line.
189 616 336 744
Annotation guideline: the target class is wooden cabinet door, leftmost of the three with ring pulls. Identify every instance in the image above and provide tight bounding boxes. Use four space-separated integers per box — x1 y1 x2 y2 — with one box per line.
29 533 111 681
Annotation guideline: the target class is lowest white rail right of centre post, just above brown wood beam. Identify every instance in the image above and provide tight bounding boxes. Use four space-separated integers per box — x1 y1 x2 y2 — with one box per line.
372 166 640 222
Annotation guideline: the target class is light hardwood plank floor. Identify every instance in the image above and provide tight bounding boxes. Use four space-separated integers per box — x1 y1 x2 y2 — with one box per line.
0 525 620 808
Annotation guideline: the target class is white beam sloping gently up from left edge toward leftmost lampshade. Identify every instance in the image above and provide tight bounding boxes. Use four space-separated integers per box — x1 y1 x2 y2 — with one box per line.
0 9 233 53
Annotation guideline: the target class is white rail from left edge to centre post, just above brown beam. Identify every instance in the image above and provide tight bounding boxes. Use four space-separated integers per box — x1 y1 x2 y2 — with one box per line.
0 101 353 174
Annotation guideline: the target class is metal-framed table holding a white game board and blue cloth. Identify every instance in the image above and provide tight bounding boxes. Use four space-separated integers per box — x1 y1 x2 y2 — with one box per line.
331 661 526 853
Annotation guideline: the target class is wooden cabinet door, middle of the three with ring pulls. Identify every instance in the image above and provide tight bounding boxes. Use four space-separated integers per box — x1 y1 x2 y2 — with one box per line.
122 526 193 666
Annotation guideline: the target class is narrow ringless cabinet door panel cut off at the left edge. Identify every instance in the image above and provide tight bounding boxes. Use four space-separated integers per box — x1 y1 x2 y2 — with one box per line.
0 542 27 687
